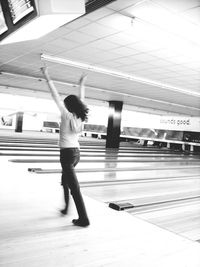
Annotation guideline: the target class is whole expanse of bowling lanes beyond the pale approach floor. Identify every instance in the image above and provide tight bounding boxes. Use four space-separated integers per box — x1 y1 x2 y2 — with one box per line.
0 133 200 245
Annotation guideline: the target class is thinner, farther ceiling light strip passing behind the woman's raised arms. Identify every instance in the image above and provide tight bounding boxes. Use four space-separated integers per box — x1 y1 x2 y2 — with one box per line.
1 71 200 111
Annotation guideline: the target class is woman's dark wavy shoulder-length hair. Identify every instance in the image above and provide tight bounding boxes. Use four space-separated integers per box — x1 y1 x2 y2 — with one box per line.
64 95 89 121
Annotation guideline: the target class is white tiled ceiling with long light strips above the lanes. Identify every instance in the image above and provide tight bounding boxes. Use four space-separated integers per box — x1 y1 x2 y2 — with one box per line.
0 0 200 116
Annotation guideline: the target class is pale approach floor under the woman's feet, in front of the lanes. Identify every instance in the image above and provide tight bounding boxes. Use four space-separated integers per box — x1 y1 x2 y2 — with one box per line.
0 158 200 267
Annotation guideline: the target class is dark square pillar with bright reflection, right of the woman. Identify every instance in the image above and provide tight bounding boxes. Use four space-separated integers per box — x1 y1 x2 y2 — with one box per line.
106 101 123 148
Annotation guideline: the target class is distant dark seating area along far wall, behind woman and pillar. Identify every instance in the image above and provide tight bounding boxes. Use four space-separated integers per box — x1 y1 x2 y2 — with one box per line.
38 121 200 152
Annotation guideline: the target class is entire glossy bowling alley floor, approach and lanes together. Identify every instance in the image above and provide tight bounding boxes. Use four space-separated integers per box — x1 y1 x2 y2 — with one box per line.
0 131 200 267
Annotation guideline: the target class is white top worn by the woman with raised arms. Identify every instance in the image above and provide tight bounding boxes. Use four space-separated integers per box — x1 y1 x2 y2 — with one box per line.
59 107 83 149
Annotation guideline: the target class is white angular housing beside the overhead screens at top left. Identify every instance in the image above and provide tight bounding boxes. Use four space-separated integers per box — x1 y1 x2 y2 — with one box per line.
0 0 85 45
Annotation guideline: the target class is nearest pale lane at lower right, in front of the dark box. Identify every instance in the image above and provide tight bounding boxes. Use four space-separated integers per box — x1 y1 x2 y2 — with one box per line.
129 197 200 241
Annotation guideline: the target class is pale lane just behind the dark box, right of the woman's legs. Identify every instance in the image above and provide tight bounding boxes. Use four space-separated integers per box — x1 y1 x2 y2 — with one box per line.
83 177 200 205
